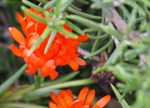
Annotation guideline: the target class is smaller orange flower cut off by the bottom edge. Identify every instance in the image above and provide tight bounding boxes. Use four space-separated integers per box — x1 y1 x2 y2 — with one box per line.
48 87 111 108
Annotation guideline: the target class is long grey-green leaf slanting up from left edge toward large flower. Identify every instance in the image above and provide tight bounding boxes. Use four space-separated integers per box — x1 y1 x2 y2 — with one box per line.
0 65 26 94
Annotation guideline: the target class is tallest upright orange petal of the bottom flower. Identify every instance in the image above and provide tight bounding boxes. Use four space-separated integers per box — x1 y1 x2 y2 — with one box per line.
78 87 88 102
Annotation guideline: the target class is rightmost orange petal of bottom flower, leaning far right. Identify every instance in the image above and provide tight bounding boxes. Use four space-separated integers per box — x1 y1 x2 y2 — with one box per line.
92 95 111 108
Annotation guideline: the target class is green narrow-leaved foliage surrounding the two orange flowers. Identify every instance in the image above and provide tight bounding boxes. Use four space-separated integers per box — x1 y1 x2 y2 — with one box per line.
0 0 150 108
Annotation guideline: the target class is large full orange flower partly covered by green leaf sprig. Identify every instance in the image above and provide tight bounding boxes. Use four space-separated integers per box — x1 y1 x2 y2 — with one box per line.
9 8 88 80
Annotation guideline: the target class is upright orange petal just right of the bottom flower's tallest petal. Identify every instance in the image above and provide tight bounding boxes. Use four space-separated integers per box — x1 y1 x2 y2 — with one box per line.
84 90 95 106
